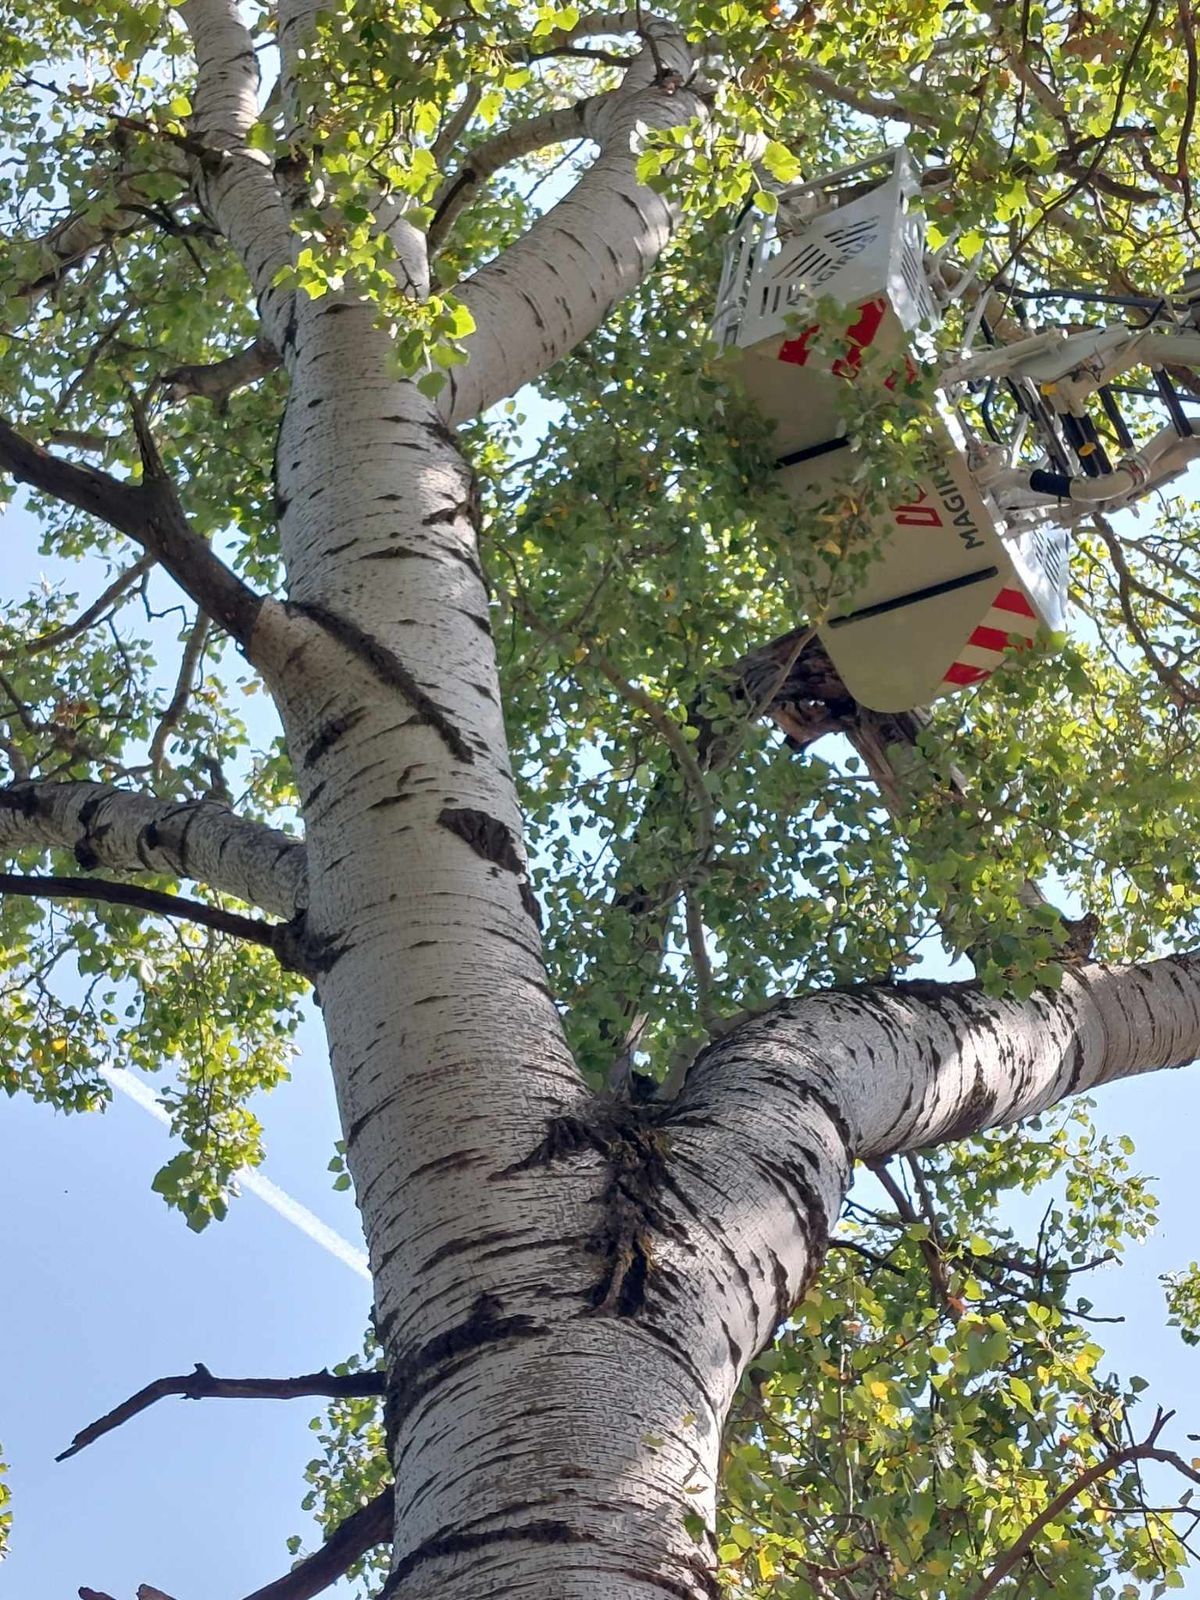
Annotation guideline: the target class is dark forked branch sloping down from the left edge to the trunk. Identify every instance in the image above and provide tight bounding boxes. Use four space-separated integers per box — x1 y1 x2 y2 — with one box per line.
0 421 264 659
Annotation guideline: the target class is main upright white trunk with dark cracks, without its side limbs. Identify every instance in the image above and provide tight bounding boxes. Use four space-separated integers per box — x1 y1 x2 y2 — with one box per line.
259 249 739 1600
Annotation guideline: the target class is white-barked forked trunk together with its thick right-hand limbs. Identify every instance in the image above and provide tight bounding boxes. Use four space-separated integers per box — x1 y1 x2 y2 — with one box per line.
249 28 1200 1600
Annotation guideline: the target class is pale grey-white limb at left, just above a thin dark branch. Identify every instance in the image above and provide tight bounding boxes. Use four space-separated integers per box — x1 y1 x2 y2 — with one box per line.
0 782 307 918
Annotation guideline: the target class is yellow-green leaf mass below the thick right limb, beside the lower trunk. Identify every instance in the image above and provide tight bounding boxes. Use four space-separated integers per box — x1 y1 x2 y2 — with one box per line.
718 1112 1184 1600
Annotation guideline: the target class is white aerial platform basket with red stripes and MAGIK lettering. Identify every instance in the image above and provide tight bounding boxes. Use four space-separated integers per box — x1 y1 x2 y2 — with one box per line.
714 149 1067 710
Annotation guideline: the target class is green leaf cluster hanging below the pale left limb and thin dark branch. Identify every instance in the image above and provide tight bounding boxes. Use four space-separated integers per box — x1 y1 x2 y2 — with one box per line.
0 870 301 1229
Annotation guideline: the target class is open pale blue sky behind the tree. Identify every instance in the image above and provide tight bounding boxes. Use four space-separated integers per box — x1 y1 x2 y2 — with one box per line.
0 457 1200 1600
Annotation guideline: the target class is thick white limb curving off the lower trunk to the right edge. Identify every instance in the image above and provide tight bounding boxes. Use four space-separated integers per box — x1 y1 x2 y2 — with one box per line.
664 957 1200 1392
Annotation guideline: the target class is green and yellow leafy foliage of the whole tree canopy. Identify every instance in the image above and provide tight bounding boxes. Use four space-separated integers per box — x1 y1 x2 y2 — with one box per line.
0 0 1200 1600
